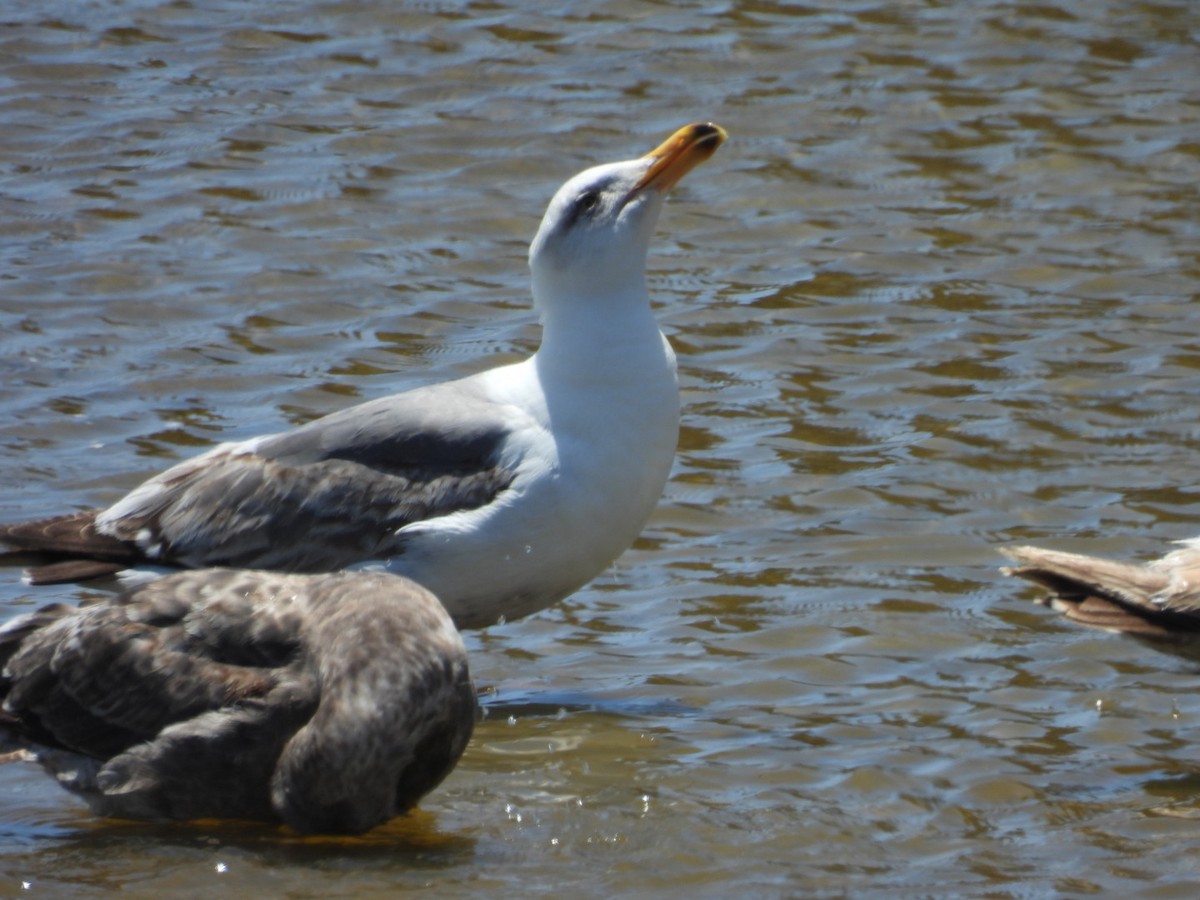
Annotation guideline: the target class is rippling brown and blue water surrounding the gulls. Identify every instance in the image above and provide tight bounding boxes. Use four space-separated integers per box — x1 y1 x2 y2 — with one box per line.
0 0 1200 898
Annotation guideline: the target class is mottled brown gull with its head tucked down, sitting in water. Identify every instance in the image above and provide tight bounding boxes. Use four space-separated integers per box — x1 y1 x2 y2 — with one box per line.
0 569 476 834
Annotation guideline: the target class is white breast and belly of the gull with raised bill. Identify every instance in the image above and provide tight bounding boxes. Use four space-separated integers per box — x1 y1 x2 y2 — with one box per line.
388 329 679 628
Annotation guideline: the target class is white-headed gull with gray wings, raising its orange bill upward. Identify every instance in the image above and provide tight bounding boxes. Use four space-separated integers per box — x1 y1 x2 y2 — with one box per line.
0 122 725 628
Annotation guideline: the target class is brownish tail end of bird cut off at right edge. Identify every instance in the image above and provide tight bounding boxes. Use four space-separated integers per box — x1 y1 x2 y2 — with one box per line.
1001 538 1200 662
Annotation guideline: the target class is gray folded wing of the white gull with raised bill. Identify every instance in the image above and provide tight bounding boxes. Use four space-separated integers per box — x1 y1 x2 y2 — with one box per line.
97 379 515 571
